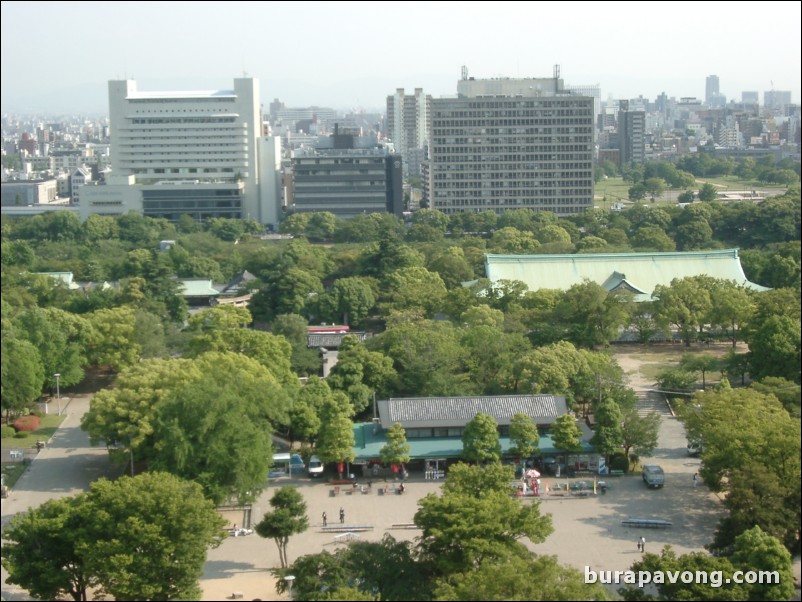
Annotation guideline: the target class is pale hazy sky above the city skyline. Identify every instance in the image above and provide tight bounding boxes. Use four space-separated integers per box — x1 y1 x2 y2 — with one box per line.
0 0 802 114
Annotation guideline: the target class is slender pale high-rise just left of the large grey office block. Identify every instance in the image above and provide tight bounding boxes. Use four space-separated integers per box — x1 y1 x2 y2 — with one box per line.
386 88 432 176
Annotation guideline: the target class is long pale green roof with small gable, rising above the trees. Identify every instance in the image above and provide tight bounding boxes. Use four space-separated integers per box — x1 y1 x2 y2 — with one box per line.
485 249 768 301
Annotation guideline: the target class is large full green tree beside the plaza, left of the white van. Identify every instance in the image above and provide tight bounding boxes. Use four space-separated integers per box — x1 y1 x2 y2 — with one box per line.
151 352 282 504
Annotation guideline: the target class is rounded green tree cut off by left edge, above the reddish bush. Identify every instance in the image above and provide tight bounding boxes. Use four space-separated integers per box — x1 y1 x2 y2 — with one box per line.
0 336 45 423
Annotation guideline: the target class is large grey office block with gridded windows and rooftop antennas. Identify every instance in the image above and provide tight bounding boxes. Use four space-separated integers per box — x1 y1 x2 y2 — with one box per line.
427 69 594 215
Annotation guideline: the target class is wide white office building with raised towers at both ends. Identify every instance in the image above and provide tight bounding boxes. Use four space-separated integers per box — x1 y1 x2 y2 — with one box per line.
94 78 278 224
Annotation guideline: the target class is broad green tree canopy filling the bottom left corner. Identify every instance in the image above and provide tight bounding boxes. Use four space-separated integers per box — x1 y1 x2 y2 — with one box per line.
3 473 225 601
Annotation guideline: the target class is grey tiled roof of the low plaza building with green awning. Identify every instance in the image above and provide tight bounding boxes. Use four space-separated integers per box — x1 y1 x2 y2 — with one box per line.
377 395 568 429
